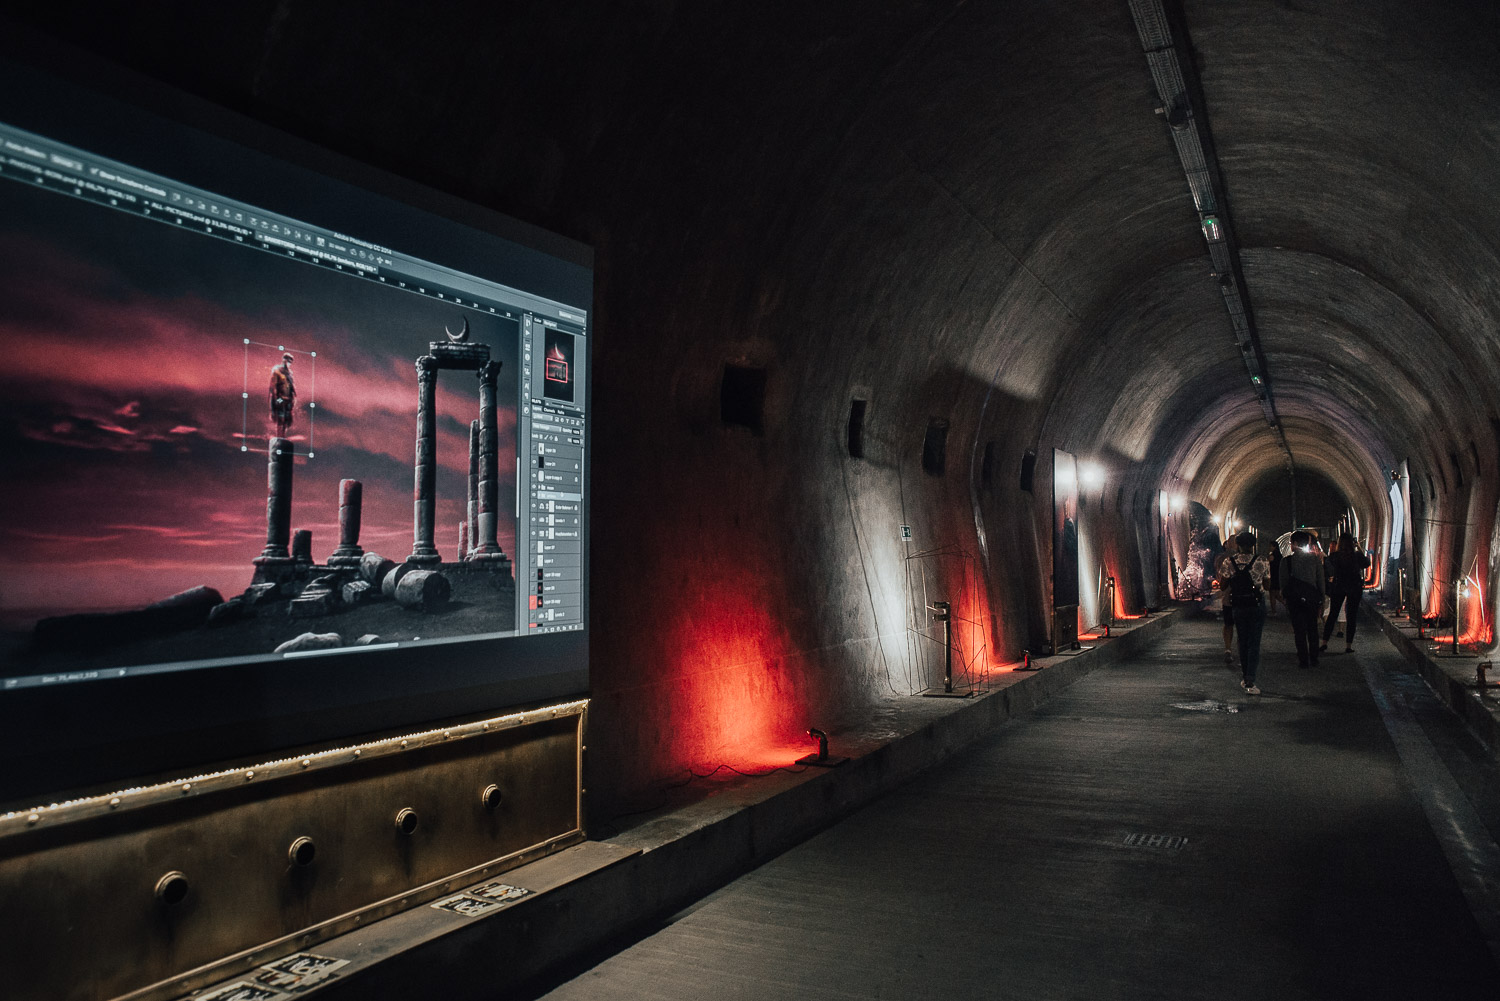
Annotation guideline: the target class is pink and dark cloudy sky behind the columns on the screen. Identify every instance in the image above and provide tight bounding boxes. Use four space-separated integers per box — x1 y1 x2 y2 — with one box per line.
0 182 518 624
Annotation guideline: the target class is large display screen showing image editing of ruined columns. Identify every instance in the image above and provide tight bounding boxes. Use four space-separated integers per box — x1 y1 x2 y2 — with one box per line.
0 46 593 798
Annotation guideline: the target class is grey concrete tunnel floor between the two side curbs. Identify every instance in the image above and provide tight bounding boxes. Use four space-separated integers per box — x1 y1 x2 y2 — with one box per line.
542 618 1500 1001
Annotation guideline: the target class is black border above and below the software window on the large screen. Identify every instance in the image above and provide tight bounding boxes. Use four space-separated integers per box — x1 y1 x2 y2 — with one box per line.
0 20 597 806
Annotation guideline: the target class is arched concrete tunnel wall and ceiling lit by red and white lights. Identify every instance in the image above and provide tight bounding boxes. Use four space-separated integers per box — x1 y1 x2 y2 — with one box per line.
14 0 1500 816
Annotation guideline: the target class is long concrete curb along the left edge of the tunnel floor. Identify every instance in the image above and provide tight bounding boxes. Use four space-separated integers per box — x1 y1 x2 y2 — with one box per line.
317 609 1185 1001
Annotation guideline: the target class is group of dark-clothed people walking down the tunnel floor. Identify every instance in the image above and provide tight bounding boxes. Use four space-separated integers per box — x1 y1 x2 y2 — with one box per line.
1215 530 1370 695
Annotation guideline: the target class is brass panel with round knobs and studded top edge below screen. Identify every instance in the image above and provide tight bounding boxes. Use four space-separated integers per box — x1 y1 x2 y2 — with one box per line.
0 711 585 1001
